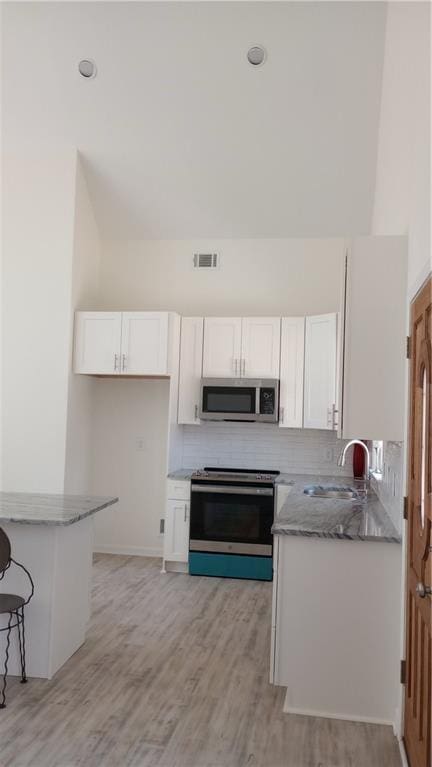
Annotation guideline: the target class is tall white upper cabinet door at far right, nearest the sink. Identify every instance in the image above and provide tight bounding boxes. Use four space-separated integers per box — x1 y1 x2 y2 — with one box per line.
303 314 337 430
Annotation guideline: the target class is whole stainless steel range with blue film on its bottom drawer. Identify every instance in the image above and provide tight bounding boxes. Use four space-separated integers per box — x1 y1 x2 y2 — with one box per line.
189 467 279 581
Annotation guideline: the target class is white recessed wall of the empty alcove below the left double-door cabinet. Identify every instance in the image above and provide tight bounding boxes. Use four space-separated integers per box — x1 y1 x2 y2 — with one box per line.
91 379 169 556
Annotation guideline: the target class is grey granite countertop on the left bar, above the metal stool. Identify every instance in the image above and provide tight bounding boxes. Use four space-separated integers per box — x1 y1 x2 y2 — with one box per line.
0 492 118 525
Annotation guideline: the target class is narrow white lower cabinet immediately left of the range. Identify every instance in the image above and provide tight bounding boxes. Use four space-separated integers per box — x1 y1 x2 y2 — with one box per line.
162 480 190 571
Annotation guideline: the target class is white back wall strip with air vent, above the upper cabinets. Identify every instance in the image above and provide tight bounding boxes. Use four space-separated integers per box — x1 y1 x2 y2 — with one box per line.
101 238 343 316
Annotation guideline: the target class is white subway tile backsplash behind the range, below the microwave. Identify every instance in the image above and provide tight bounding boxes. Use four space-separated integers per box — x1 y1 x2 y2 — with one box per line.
183 423 352 476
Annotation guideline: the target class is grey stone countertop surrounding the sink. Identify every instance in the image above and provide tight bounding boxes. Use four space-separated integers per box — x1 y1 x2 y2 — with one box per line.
272 474 402 543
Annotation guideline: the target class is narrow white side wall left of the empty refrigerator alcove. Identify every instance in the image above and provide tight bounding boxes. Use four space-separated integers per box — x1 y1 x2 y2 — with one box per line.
64 157 100 493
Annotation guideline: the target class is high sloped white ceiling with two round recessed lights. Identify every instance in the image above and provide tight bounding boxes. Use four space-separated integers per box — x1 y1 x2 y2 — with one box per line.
3 1 385 238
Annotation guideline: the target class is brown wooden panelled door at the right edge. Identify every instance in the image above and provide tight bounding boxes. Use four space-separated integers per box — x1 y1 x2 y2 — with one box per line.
404 278 432 767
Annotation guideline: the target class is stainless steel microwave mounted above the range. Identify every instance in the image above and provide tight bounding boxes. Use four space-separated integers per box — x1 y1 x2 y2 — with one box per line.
200 378 279 423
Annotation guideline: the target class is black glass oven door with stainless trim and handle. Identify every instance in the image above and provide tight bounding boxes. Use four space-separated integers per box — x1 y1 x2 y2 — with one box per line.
189 483 274 557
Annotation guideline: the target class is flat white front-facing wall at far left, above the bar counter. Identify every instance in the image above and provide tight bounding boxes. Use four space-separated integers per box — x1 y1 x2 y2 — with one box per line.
2 145 76 492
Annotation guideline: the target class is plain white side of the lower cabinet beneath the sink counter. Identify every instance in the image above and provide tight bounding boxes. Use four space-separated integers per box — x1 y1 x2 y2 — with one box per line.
270 535 402 724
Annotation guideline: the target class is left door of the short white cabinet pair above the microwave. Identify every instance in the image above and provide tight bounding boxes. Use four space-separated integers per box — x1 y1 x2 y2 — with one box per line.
203 317 242 378
